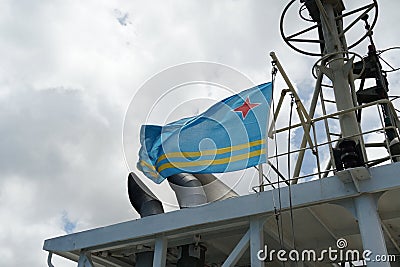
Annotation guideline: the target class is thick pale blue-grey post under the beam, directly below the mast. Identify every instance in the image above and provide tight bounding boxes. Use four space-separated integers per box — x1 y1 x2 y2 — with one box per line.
354 194 390 267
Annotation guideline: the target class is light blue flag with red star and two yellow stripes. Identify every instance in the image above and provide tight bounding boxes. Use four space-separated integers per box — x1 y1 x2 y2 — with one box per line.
137 83 272 183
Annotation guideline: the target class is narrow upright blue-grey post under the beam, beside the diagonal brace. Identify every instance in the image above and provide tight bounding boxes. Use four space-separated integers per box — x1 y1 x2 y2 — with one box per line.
250 218 265 267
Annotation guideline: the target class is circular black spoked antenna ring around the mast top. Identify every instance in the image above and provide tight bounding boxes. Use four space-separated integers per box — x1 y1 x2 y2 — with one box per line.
280 0 378 56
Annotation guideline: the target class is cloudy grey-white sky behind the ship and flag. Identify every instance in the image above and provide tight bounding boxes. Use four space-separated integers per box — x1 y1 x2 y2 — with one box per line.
0 0 400 267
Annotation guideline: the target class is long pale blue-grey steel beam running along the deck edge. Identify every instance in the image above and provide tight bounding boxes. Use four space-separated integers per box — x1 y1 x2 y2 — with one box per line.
43 163 400 260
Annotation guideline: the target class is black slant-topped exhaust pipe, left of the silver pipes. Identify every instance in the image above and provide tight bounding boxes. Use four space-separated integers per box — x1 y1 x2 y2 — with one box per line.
128 172 164 267
